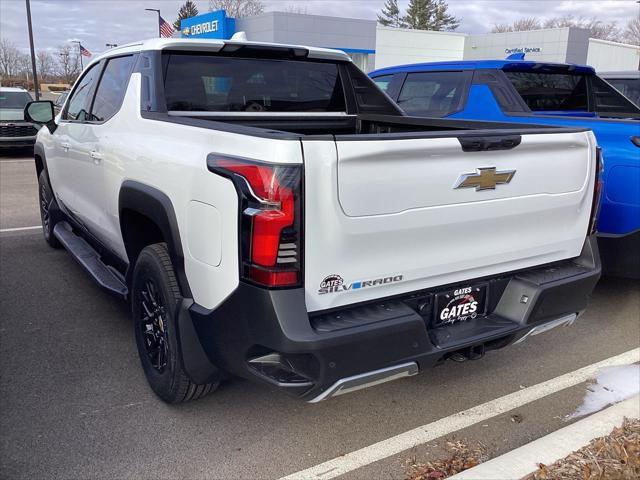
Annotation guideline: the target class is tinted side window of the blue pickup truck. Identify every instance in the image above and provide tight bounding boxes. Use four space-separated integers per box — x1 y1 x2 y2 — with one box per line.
398 72 470 117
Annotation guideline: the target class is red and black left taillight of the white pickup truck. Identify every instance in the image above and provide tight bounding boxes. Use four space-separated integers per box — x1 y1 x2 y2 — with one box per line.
207 154 302 287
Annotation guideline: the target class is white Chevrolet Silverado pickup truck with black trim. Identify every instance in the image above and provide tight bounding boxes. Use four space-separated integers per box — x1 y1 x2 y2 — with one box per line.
25 39 600 402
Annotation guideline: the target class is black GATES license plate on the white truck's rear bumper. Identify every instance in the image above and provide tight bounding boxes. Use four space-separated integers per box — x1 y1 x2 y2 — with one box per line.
433 283 487 327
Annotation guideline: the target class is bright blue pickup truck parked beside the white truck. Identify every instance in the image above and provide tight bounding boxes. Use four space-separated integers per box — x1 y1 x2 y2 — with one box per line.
369 57 640 278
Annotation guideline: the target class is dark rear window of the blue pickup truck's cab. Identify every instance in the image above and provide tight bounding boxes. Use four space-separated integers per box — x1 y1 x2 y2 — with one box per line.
504 71 589 112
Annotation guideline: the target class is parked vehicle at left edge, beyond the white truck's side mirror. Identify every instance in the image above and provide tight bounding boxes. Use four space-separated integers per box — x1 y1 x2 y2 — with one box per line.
0 87 38 148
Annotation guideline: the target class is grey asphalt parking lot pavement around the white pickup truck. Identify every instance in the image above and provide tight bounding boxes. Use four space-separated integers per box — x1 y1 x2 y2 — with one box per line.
0 152 640 479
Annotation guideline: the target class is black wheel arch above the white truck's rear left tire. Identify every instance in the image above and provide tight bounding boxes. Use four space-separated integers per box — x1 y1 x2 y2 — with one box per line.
118 180 192 298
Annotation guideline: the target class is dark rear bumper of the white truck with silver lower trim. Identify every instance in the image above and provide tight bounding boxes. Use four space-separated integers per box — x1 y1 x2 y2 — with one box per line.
180 237 600 401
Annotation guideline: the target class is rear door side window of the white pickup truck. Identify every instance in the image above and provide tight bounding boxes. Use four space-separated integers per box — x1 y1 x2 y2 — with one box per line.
91 55 133 122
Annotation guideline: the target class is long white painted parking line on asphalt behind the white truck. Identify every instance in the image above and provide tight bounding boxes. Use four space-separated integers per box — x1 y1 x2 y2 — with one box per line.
280 348 640 480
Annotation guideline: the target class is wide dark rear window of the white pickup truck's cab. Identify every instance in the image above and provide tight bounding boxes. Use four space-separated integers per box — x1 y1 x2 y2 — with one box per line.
165 53 345 112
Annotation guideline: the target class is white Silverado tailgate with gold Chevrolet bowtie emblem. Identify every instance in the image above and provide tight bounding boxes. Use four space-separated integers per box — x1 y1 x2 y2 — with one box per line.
303 132 595 311
